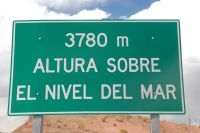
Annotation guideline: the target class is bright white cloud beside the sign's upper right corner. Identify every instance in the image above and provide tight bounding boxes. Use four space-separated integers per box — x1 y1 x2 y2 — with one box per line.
130 0 200 58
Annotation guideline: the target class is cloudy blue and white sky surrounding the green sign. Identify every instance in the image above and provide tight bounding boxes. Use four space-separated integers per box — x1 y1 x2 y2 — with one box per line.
0 0 200 132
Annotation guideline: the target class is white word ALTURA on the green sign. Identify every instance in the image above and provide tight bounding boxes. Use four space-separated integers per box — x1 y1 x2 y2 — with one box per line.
33 58 98 73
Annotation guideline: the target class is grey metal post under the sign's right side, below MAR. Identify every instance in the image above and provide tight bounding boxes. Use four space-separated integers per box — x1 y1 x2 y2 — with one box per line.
151 114 160 133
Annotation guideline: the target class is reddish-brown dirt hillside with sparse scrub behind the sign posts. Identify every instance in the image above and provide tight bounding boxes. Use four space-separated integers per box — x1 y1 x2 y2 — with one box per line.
13 115 200 133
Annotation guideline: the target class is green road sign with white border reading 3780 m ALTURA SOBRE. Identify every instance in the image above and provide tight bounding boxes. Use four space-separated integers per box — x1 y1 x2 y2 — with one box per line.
8 20 185 115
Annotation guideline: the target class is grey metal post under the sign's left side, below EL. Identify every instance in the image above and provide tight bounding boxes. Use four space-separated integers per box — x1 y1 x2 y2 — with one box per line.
33 115 43 133
